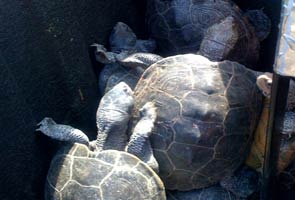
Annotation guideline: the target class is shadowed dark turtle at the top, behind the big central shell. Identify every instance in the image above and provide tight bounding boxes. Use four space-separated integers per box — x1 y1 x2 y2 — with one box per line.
146 0 271 69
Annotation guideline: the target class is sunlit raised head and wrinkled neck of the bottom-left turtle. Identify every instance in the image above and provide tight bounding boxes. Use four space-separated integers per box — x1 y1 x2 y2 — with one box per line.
96 83 134 151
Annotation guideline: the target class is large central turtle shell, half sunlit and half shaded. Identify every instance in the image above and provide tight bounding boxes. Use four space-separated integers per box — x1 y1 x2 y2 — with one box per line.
132 54 262 190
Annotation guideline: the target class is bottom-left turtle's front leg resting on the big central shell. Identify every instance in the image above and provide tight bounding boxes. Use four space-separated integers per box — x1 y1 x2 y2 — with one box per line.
126 102 159 173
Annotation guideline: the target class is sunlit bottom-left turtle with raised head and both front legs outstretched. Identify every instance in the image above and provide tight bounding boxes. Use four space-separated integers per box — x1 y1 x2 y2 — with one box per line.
37 82 166 200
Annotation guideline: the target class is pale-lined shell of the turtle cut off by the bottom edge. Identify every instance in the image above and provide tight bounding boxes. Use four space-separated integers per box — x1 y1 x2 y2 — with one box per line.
45 143 166 200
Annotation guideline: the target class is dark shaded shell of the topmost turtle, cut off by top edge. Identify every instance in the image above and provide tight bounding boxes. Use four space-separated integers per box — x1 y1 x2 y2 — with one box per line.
147 0 259 66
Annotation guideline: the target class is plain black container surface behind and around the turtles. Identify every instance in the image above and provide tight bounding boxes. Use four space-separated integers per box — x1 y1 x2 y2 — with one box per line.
0 0 280 200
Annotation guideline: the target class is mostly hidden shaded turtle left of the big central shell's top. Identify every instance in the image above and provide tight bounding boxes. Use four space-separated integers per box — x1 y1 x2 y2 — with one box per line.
92 22 163 95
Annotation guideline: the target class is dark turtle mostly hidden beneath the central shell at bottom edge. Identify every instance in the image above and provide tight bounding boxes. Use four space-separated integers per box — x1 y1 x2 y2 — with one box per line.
166 166 260 200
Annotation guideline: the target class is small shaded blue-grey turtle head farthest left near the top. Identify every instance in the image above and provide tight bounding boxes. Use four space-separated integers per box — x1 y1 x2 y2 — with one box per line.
109 22 137 53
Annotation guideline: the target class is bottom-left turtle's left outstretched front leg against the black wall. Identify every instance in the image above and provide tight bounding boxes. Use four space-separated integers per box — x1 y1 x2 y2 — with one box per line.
36 117 89 146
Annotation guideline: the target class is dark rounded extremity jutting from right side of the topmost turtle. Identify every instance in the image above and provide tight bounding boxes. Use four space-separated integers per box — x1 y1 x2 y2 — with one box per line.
245 9 271 41
